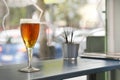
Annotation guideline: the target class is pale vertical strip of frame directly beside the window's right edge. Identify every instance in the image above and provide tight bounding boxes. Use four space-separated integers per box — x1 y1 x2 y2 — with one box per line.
107 0 114 52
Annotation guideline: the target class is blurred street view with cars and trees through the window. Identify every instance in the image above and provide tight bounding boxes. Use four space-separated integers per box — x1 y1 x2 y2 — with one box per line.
0 0 106 65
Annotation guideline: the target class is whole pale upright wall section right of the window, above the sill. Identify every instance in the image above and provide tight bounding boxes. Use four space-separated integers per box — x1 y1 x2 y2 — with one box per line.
107 0 120 53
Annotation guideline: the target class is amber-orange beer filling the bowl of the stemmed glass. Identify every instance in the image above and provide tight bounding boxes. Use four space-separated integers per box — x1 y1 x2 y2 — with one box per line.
21 23 40 48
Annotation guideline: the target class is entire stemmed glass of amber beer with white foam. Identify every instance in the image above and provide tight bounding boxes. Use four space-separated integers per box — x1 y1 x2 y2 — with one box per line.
20 19 40 72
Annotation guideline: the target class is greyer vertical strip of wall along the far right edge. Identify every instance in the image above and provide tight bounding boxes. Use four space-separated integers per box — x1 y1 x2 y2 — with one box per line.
114 0 120 52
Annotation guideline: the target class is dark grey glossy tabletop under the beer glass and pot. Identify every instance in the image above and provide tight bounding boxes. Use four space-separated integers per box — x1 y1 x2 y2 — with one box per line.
0 58 120 80
